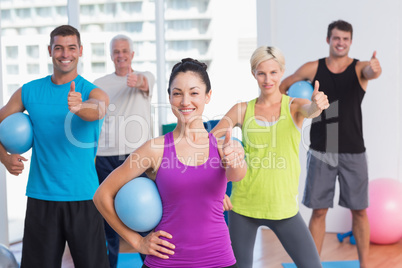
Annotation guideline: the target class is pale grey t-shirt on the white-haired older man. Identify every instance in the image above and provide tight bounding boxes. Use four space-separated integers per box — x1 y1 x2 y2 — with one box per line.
94 72 155 156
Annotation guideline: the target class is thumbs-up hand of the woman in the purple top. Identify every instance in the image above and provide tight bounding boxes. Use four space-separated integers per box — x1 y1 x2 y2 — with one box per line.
222 127 244 168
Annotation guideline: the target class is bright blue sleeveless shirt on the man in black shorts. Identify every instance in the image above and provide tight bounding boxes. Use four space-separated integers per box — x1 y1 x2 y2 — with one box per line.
21 76 103 201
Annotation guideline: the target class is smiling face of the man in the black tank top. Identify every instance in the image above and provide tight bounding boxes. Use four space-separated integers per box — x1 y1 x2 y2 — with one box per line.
327 28 352 57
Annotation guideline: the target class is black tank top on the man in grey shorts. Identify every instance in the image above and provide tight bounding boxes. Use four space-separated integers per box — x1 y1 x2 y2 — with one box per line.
310 58 366 153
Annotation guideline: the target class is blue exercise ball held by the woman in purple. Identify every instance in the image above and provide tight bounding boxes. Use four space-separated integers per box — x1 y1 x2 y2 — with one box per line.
114 177 162 232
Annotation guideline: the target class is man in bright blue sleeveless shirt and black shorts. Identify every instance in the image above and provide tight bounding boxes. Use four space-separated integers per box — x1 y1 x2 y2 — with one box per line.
0 25 109 268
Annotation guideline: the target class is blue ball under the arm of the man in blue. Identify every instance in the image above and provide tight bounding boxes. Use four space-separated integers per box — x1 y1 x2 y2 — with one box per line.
0 113 33 154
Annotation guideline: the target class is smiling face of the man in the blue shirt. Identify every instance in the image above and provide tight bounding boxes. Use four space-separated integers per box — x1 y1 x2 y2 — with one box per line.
48 35 82 75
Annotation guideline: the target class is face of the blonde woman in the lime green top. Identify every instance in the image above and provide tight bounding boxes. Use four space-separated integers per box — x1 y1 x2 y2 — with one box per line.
253 59 283 94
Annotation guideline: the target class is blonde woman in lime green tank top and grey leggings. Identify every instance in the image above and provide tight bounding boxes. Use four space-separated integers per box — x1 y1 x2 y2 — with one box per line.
212 46 329 268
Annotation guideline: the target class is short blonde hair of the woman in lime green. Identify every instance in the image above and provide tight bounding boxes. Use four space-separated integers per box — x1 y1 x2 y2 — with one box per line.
250 46 285 73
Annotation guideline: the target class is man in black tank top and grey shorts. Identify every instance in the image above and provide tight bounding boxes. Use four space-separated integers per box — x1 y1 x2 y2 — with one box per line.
280 20 381 268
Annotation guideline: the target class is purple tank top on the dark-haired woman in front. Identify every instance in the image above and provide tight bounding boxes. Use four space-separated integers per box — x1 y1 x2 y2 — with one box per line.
145 132 236 268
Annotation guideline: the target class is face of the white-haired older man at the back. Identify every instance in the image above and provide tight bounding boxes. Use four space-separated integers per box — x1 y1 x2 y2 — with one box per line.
111 40 134 75
